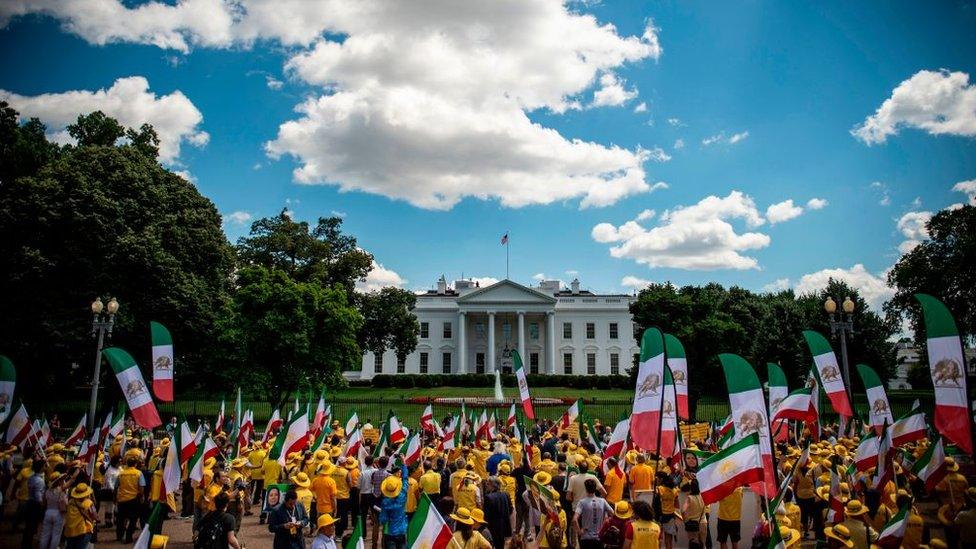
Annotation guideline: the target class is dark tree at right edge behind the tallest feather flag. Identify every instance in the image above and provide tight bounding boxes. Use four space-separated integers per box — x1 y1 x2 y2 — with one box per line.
885 206 976 342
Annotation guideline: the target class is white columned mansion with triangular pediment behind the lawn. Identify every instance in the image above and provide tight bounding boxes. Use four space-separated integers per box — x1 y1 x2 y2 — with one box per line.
347 277 640 379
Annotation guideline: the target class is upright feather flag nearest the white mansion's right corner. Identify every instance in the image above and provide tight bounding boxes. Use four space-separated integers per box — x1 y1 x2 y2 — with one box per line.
630 328 664 450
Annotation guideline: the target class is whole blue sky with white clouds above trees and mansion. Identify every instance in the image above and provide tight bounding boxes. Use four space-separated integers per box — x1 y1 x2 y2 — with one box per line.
0 0 976 310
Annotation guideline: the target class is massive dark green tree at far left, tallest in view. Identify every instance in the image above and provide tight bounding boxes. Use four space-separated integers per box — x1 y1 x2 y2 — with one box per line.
0 108 234 396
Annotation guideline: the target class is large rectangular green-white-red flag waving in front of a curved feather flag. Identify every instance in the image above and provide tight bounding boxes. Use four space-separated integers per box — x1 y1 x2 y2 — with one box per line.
697 432 775 505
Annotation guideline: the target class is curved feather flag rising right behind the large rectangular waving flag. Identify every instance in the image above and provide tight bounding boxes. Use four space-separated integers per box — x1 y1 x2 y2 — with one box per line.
718 353 777 497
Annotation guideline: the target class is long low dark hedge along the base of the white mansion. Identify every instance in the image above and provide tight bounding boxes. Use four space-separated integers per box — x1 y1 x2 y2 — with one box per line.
368 374 633 389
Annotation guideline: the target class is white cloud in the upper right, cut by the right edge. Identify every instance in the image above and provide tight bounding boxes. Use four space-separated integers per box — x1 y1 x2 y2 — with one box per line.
851 69 976 145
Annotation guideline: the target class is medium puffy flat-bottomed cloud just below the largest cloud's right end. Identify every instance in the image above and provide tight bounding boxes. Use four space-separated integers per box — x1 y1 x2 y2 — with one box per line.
591 191 770 270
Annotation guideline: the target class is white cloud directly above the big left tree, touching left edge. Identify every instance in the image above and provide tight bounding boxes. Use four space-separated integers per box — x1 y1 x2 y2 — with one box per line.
0 76 210 164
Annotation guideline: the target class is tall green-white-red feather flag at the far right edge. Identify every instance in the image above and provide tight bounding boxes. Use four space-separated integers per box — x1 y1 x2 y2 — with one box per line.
915 294 973 455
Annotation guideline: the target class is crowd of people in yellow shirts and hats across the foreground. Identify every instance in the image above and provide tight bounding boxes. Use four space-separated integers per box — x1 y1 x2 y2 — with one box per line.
0 412 976 549
